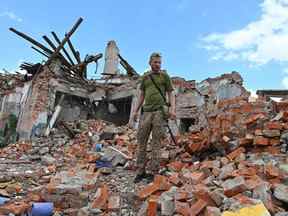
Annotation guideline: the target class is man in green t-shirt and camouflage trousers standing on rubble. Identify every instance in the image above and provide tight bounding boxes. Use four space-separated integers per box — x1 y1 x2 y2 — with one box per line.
133 53 176 183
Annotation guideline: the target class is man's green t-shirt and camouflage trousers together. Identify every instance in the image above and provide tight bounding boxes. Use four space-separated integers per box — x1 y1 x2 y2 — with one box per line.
136 71 173 174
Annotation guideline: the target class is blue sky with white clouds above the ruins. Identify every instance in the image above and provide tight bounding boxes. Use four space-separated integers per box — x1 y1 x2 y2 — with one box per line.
0 0 288 91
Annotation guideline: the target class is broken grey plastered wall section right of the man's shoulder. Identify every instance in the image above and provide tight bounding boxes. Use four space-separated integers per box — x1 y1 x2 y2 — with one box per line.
173 72 250 132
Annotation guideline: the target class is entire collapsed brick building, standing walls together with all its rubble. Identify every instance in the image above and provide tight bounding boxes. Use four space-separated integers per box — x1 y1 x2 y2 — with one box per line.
0 19 288 216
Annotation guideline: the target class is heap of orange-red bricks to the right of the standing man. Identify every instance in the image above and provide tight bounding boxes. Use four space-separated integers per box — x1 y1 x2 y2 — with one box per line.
133 98 288 216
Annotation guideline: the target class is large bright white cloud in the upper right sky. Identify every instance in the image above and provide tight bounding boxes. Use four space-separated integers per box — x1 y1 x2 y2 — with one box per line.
202 0 288 65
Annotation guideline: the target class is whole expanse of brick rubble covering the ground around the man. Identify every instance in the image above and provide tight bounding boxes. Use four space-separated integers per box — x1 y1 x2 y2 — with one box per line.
0 98 288 216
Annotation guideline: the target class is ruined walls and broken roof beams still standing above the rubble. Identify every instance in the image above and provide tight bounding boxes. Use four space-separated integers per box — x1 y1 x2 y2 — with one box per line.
0 17 249 145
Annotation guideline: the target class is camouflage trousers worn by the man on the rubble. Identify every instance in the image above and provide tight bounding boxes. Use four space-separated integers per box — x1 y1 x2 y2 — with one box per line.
136 111 165 174
